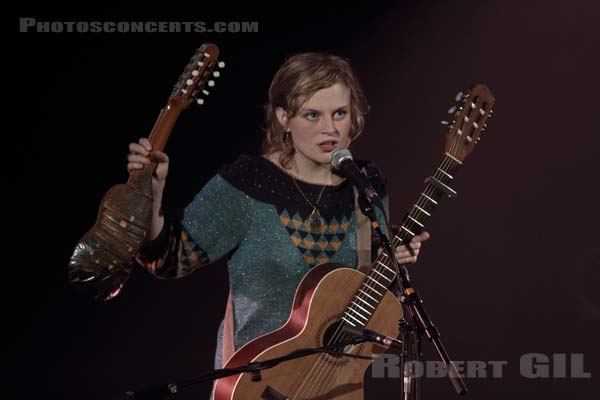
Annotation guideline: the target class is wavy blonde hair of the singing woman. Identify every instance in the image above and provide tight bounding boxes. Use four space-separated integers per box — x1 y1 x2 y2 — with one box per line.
262 52 369 168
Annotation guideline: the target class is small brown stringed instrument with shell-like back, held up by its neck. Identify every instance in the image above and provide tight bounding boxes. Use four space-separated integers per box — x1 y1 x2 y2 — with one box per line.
68 43 224 300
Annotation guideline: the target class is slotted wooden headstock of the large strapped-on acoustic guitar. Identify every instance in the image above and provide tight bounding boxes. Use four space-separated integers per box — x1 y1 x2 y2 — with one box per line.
445 84 496 161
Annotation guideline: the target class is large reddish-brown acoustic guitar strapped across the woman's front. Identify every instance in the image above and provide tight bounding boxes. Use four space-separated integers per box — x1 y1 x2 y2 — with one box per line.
214 85 495 400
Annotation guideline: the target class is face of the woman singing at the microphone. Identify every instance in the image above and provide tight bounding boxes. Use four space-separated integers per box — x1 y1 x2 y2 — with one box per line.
278 83 351 167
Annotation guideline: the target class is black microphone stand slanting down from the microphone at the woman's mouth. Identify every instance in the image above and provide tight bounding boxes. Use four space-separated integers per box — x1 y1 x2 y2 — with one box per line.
358 196 467 399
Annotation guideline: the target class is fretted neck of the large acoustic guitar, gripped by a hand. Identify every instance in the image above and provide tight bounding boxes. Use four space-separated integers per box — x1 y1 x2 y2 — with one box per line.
342 153 462 326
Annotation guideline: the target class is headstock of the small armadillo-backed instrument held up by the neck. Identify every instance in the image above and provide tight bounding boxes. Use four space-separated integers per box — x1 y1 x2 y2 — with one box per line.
170 43 225 109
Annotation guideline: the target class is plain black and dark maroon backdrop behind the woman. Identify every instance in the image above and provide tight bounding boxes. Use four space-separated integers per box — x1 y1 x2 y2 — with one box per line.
3 1 600 399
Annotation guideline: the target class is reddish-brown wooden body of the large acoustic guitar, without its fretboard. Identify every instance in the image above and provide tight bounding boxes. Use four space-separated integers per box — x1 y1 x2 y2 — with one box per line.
214 264 402 400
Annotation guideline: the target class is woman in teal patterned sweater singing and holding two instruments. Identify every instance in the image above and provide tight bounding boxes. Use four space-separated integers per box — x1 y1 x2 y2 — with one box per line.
127 53 429 368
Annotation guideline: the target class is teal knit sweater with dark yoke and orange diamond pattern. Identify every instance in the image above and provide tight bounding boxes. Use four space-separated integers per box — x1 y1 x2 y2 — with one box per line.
138 156 387 368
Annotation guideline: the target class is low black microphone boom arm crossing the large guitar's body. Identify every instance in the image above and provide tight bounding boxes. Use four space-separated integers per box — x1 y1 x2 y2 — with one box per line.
115 336 372 400
